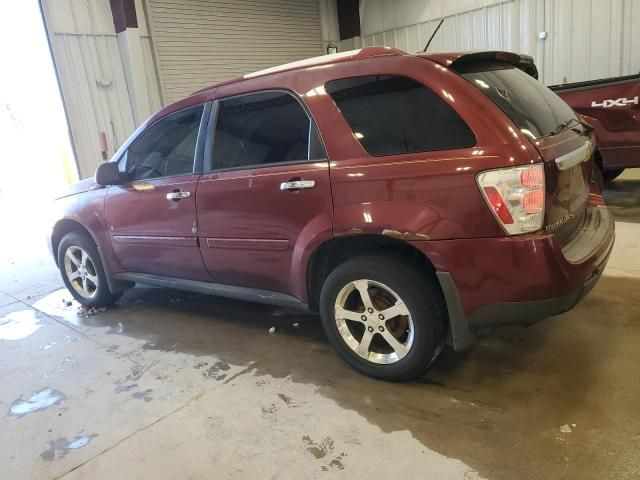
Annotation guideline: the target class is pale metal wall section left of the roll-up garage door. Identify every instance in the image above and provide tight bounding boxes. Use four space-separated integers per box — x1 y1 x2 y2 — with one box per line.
42 0 160 178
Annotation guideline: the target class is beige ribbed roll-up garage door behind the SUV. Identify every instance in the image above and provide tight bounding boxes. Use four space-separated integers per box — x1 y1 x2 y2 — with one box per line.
146 0 322 103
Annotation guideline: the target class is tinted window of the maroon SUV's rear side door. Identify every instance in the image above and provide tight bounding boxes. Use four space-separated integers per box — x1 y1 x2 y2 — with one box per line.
213 92 326 169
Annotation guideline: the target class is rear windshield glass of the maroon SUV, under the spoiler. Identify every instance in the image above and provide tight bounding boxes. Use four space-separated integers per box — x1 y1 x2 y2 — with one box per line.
454 62 577 138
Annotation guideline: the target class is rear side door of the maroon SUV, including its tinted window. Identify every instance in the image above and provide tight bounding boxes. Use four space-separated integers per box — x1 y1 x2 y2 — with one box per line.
196 91 332 295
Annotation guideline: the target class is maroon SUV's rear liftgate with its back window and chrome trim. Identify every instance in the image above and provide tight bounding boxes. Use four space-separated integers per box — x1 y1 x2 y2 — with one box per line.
454 62 593 239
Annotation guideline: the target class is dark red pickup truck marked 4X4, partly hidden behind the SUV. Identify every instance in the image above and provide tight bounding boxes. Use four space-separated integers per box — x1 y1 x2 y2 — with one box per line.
549 73 640 182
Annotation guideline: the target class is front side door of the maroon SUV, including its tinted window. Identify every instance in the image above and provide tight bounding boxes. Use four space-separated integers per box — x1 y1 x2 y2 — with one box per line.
105 105 209 280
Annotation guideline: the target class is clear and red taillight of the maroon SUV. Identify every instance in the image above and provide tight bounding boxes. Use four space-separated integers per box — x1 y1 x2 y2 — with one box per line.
477 163 544 235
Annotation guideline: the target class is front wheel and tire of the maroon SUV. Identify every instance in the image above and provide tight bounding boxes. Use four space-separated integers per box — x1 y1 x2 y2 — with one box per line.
58 231 122 308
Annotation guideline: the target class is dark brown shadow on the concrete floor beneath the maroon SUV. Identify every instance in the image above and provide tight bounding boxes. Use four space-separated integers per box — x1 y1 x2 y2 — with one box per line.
32 270 640 479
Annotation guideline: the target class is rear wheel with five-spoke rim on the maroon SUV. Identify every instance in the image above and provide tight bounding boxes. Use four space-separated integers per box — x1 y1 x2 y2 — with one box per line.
320 255 447 381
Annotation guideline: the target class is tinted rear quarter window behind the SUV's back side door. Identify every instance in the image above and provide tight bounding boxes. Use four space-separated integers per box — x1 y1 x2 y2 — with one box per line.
325 75 476 156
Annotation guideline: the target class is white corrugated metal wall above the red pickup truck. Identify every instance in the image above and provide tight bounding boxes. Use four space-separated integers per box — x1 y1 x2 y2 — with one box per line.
362 0 640 85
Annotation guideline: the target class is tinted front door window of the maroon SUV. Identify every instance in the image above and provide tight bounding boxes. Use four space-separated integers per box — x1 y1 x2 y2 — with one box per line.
126 106 204 181
